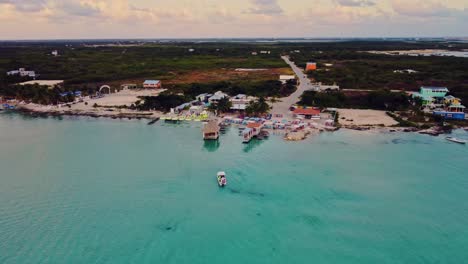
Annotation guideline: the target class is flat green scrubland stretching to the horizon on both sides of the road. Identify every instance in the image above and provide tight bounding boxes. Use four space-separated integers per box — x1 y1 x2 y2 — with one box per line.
0 40 468 105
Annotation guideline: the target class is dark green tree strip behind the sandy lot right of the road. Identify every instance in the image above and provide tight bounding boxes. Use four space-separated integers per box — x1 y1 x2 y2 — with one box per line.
299 90 412 111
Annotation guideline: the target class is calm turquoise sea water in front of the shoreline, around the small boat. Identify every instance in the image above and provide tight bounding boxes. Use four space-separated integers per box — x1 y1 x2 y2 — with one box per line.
0 113 468 264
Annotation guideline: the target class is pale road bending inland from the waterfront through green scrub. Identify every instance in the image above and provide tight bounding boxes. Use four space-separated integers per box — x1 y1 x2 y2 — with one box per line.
271 56 313 117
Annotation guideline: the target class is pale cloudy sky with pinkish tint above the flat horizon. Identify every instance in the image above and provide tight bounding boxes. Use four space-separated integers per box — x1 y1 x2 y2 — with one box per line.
0 0 468 40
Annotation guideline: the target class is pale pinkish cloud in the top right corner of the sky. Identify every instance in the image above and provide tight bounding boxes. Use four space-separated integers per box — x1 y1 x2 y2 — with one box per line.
391 0 464 17
